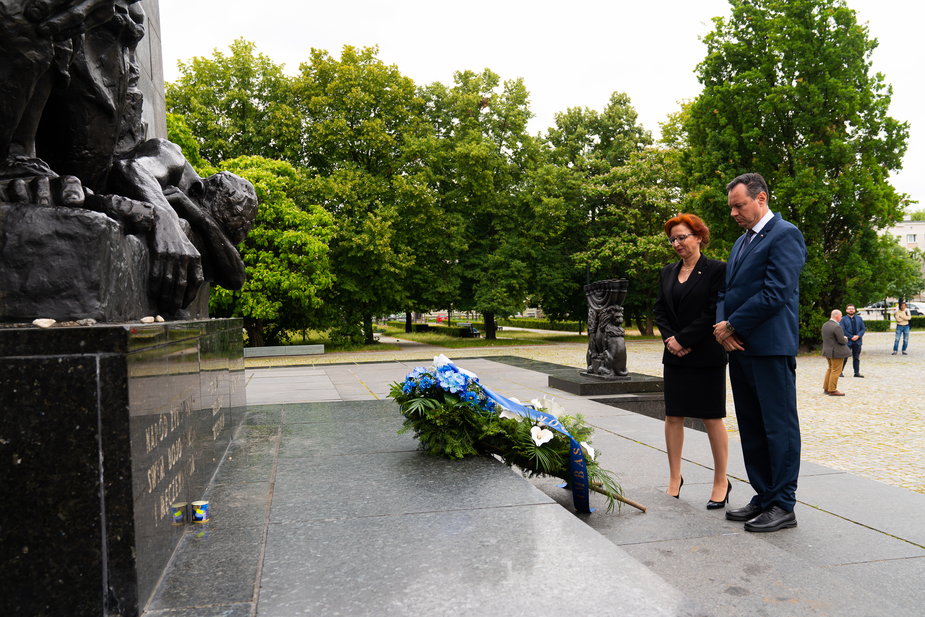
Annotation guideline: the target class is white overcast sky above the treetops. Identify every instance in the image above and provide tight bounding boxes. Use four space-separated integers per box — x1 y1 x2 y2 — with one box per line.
160 0 925 209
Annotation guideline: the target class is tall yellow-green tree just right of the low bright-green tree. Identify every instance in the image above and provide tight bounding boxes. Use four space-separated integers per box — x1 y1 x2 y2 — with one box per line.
293 46 441 343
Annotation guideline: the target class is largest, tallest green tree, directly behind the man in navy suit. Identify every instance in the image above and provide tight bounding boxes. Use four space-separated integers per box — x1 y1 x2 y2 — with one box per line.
683 0 908 338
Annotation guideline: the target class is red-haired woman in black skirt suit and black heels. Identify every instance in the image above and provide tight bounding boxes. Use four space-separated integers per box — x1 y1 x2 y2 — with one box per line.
655 213 732 510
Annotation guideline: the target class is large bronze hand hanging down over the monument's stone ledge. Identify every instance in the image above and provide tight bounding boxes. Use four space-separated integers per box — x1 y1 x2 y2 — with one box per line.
151 206 203 314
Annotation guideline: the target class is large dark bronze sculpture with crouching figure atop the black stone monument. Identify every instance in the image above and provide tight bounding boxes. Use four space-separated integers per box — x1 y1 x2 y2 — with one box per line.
0 0 256 320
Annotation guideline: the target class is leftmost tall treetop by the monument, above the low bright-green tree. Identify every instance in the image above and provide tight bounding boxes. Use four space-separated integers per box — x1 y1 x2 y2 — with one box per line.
166 39 303 166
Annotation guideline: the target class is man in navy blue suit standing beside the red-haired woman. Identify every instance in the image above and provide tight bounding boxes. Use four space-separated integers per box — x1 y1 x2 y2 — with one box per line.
713 173 806 531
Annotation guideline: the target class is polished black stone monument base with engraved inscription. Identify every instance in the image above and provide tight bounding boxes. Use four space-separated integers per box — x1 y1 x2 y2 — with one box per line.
0 319 246 617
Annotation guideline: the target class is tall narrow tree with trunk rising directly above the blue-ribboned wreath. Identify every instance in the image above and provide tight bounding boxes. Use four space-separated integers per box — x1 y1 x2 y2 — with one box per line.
422 69 538 339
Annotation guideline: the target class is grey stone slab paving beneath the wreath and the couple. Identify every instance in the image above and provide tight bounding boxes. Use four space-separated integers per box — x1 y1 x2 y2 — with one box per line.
145 350 925 617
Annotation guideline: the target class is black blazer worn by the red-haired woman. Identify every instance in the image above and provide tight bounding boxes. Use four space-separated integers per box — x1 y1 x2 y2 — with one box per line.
654 255 726 366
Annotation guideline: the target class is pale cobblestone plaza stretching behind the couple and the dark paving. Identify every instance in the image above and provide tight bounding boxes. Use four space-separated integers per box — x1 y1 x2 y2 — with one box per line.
242 332 925 494
